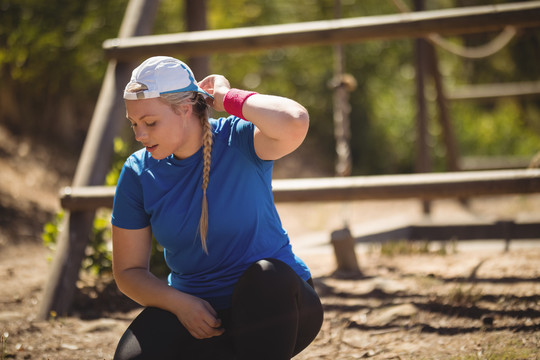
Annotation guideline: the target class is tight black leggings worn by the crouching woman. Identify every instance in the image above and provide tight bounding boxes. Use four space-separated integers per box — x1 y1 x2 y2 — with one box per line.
114 259 323 360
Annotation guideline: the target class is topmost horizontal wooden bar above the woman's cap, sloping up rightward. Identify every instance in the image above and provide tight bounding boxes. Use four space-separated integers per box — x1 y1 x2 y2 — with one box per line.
103 1 540 61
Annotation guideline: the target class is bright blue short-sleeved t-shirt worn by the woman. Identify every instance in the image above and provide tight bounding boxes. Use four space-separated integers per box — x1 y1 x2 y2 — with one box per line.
112 116 311 309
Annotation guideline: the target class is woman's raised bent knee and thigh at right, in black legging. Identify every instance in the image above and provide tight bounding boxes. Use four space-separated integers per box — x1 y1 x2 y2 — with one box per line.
231 259 323 359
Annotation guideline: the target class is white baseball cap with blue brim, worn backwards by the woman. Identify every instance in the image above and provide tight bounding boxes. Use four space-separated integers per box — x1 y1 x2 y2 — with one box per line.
124 56 213 100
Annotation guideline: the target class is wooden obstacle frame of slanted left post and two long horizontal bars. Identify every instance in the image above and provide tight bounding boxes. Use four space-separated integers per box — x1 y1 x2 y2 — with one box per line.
38 0 540 319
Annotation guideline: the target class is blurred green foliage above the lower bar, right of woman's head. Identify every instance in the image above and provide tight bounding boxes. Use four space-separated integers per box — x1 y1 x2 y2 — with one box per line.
204 0 540 174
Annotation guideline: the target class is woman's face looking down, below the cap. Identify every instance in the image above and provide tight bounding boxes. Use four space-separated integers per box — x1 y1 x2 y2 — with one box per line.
126 98 201 159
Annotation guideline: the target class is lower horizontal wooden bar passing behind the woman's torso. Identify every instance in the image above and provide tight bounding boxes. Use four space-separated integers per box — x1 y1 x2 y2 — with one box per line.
60 169 540 211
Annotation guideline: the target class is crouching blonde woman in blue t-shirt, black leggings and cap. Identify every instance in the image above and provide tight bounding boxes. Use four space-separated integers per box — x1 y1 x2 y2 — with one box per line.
112 56 323 360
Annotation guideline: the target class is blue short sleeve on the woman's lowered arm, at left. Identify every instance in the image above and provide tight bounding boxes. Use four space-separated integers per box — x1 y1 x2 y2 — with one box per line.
111 158 150 230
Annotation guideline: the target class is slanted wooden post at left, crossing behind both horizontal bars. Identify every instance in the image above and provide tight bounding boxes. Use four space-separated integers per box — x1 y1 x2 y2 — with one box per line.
38 0 158 319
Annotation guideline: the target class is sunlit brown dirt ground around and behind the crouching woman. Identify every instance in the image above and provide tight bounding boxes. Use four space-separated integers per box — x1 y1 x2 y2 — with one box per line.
0 124 540 360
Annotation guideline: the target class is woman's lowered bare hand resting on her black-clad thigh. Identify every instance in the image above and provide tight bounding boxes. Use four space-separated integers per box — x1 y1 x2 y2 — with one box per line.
174 293 225 339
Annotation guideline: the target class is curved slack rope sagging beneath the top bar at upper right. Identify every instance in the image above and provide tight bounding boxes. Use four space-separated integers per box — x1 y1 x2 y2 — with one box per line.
392 0 517 59
